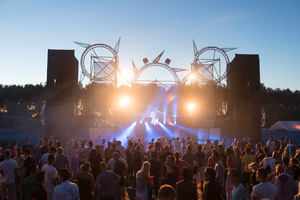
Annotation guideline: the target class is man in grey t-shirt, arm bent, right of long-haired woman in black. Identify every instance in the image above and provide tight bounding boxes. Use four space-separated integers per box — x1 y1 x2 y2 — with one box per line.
95 161 121 200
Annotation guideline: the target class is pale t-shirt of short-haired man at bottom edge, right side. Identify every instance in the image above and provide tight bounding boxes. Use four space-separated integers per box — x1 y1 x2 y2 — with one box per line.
251 182 277 200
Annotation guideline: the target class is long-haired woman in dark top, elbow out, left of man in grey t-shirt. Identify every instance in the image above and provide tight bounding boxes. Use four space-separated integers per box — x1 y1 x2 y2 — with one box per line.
70 161 94 200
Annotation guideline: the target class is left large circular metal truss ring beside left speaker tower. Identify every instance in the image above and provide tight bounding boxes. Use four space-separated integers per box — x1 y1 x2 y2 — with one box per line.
80 44 119 81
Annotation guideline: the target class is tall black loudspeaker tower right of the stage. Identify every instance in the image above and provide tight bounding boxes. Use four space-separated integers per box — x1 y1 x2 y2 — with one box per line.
227 54 261 140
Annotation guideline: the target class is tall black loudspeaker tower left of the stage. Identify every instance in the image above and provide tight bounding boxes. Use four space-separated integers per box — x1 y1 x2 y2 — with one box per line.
45 50 78 141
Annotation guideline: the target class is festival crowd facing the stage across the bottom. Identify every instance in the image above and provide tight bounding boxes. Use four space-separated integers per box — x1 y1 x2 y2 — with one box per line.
0 137 300 200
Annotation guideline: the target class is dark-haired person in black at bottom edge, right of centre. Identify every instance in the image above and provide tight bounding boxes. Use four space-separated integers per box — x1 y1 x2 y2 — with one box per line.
202 167 222 200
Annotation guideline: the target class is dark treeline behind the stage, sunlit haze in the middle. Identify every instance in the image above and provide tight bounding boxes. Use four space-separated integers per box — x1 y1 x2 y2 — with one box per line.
0 84 300 127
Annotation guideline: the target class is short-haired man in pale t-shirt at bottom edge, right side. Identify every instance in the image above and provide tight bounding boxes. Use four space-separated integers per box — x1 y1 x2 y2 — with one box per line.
251 168 277 200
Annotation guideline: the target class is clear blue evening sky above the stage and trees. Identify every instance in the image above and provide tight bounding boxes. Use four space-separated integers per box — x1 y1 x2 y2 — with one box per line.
0 0 300 91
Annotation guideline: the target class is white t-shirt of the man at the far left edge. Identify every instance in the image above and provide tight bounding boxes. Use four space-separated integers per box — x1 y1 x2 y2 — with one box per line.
0 159 18 184
